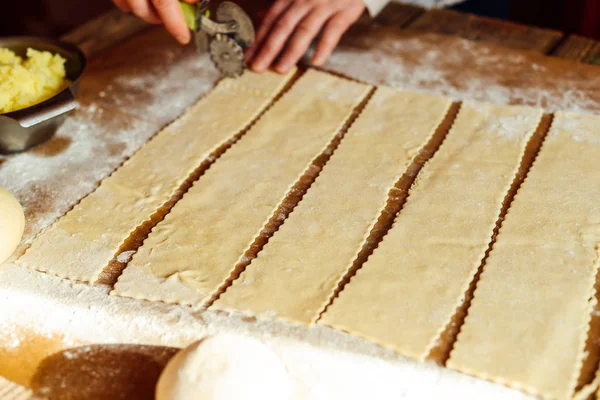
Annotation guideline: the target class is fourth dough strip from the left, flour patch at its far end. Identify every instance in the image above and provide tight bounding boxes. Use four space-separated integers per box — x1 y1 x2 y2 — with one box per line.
319 102 542 360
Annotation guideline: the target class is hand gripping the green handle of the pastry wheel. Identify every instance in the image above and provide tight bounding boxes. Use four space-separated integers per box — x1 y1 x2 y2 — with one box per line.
113 0 198 44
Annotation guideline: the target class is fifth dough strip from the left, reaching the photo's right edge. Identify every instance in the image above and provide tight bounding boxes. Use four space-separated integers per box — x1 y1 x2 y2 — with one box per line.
448 112 600 399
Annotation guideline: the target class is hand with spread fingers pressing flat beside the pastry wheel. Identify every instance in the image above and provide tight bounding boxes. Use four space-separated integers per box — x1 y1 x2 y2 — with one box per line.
246 0 365 73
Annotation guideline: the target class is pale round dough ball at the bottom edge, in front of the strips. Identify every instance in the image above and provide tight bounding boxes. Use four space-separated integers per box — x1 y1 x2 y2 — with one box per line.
156 334 291 400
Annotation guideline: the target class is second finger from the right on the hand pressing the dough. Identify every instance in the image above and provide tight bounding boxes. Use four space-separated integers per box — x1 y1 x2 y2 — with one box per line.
275 9 331 73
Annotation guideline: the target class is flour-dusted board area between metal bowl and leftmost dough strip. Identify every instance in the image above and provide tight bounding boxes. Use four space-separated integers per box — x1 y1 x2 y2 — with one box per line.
0 52 218 254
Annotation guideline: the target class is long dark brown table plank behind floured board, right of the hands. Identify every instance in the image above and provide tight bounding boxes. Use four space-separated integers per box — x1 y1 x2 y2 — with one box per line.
409 9 563 53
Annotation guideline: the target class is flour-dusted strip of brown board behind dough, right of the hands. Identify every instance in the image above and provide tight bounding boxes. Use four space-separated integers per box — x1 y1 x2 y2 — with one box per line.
325 27 600 113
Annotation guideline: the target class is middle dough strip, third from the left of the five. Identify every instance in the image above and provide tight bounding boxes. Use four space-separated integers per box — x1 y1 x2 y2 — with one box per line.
214 87 452 325
